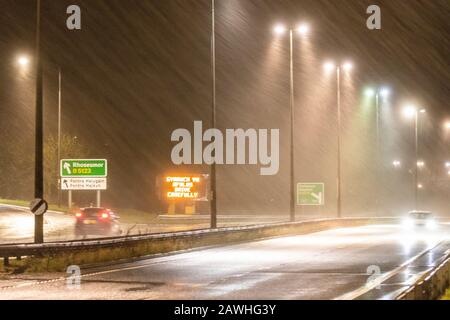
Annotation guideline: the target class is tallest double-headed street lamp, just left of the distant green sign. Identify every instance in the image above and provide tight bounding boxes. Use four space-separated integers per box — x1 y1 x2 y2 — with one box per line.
273 24 309 222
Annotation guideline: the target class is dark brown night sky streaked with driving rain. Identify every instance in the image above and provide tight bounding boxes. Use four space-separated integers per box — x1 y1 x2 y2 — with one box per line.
0 0 450 212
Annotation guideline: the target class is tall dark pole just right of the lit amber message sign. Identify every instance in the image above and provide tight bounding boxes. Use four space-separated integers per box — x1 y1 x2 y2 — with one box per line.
210 0 217 229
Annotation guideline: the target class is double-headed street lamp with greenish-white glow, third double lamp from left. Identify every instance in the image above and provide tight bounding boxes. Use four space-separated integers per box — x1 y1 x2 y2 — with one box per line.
366 87 391 212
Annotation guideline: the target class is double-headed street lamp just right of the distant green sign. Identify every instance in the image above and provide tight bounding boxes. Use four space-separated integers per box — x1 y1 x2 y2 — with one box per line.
324 61 353 218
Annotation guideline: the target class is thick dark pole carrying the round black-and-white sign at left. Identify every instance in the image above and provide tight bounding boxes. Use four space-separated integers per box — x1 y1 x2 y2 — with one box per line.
34 0 44 243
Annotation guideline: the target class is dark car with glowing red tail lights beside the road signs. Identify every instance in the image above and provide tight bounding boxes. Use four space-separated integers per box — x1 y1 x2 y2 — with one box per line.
75 208 122 236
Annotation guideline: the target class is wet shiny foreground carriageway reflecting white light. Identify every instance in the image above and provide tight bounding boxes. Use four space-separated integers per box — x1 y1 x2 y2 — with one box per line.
0 225 450 299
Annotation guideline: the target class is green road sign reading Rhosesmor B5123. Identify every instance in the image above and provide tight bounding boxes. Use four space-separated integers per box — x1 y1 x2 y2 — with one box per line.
61 159 108 178
